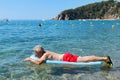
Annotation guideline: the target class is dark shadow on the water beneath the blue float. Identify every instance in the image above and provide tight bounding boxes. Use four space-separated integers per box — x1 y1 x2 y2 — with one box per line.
50 65 112 75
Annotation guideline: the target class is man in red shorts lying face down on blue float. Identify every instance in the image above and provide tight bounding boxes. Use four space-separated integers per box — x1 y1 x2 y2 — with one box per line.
24 45 113 67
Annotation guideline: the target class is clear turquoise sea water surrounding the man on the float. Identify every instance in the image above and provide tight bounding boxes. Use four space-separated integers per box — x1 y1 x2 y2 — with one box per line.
0 20 120 80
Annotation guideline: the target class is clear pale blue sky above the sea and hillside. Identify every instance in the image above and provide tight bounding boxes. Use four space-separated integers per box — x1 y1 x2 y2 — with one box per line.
0 0 102 20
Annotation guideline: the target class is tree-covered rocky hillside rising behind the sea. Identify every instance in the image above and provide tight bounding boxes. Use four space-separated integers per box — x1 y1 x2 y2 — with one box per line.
53 0 120 20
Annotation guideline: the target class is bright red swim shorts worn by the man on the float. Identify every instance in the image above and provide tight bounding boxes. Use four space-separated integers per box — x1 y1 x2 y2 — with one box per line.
63 52 78 62
